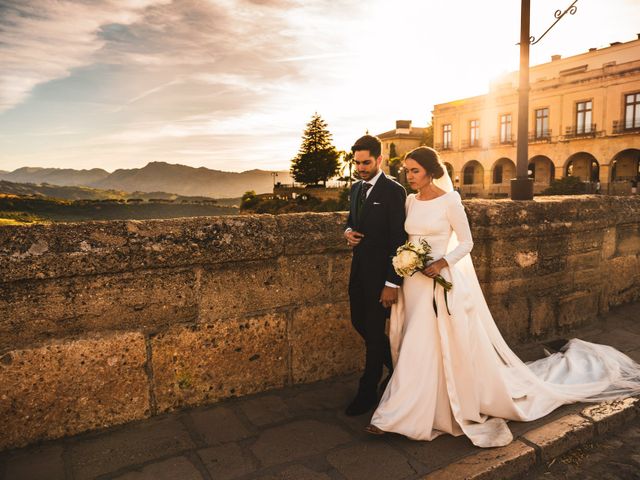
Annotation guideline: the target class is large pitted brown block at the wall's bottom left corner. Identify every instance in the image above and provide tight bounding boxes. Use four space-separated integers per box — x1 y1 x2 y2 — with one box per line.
0 333 150 449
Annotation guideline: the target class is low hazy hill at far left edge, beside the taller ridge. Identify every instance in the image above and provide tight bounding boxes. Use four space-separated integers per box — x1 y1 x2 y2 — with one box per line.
0 167 109 186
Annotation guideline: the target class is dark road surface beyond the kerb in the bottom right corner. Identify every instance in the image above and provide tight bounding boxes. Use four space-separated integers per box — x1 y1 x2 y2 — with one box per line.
522 419 640 480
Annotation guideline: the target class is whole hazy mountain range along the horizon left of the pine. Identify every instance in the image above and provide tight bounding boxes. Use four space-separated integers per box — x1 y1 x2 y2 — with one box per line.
0 162 293 198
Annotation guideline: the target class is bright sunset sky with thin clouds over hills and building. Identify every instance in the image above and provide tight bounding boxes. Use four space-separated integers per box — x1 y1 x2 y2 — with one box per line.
0 0 640 171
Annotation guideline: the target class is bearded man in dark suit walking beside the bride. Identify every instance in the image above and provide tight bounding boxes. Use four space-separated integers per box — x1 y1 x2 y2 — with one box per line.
344 135 407 416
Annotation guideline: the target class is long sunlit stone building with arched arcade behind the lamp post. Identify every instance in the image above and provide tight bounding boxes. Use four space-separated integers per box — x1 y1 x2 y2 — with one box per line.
433 35 640 197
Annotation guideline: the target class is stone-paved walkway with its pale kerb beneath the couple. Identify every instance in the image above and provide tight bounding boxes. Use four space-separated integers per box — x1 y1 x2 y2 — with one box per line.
0 303 640 480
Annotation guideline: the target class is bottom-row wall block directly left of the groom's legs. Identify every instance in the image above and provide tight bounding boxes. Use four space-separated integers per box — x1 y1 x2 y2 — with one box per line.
289 302 364 383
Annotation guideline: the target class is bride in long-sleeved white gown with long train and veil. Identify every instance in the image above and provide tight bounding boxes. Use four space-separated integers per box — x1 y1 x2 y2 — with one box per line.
366 147 640 447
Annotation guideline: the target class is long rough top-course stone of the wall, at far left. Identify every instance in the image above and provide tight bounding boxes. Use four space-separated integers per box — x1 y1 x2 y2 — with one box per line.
0 215 284 282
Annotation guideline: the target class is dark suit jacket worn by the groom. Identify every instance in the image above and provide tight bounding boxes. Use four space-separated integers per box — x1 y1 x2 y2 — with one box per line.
347 173 407 294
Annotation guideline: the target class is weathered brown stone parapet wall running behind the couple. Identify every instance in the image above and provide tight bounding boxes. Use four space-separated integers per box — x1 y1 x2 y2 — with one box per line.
0 196 640 449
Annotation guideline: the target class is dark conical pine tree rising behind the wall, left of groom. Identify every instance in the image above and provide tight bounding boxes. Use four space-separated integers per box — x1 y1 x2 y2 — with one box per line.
291 112 339 186
